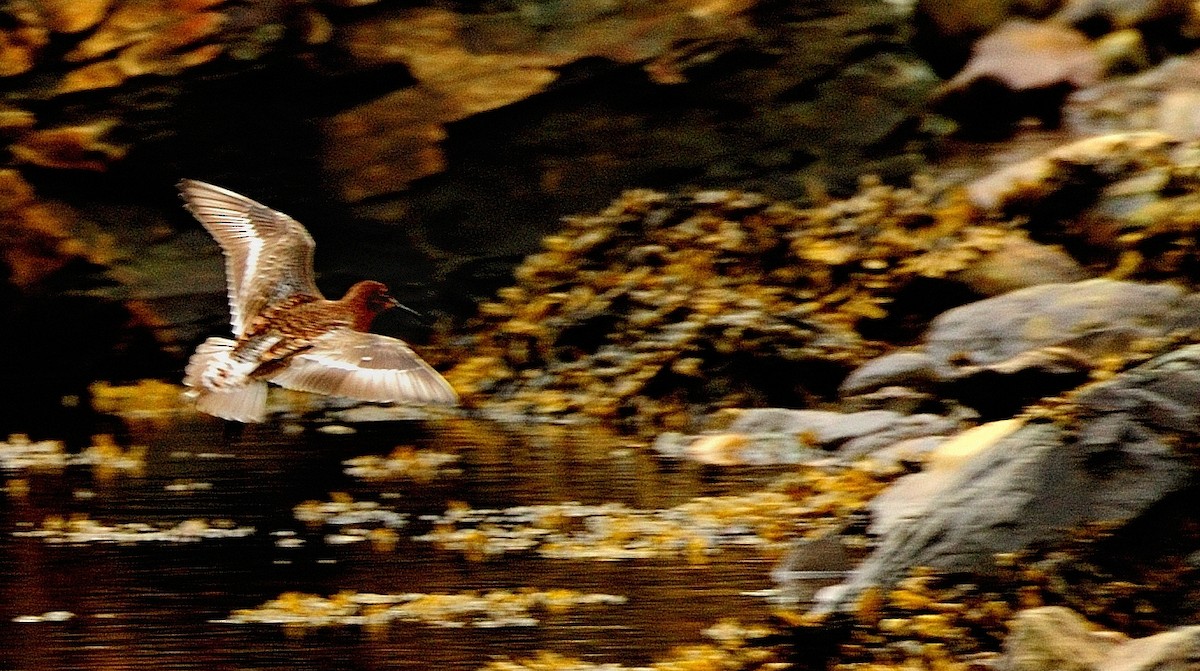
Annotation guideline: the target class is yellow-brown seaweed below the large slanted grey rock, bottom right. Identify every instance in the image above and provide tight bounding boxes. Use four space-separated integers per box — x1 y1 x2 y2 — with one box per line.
796 525 1196 671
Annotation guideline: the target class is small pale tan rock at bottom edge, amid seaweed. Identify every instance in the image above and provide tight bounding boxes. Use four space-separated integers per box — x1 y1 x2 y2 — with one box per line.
1001 606 1122 671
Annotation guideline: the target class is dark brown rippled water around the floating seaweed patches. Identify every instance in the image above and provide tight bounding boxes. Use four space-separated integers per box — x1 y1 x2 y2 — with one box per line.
0 415 792 670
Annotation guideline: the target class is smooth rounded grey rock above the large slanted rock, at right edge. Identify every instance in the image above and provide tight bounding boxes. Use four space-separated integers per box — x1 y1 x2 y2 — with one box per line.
840 280 1200 417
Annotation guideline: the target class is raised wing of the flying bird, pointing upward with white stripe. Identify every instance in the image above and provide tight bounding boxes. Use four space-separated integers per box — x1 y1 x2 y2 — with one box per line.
179 179 320 336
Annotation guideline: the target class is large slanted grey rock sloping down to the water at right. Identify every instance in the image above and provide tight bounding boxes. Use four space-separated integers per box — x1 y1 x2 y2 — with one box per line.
816 346 1200 613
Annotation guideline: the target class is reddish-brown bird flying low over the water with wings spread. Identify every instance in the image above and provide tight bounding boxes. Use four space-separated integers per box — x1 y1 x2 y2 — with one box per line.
179 179 458 423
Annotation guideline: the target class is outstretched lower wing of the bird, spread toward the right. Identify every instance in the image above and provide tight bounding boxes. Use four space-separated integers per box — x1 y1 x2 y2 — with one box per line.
270 328 458 406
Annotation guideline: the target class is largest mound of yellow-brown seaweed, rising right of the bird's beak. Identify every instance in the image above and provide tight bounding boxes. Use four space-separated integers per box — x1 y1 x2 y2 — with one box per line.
440 138 1200 432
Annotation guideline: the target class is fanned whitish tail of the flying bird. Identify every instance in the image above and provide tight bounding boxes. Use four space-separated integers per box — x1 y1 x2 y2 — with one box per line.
184 337 266 421
